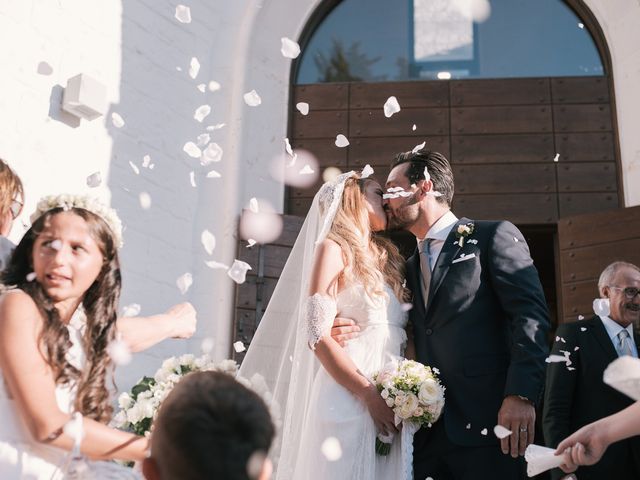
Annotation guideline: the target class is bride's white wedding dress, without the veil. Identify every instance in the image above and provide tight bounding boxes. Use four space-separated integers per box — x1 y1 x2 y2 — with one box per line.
288 284 413 480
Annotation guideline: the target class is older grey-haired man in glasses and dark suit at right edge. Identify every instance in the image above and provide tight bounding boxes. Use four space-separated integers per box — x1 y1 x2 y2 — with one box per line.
543 262 640 480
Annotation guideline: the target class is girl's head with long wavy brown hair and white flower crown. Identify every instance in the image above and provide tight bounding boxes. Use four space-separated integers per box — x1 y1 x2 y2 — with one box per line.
2 197 121 421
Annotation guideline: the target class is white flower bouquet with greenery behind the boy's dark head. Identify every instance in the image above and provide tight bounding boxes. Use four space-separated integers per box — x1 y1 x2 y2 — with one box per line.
112 354 272 435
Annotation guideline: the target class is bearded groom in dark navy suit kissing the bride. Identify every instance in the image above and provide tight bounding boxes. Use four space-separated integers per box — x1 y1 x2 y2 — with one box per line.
332 150 549 480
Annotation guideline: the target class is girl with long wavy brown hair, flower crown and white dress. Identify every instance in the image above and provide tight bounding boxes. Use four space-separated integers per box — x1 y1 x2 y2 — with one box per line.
0 196 147 480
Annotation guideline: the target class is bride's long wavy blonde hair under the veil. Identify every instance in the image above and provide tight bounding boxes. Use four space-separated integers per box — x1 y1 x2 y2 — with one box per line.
327 173 408 301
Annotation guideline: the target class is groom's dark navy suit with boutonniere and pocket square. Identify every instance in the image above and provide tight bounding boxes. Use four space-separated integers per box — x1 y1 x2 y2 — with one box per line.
407 218 549 480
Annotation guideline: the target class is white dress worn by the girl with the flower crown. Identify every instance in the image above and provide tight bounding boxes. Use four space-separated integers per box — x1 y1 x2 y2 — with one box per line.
0 300 86 480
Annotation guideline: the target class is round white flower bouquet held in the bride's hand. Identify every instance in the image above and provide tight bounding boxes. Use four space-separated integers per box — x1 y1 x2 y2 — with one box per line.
373 359 445 455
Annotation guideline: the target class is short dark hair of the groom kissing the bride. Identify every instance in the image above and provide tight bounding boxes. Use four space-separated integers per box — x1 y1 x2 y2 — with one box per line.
391 150 454 207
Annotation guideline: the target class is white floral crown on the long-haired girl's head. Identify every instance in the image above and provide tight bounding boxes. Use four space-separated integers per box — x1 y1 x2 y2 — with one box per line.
31 194 123 248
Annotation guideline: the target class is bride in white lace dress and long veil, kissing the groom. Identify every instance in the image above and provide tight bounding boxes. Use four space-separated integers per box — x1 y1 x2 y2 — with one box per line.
240 167 412 480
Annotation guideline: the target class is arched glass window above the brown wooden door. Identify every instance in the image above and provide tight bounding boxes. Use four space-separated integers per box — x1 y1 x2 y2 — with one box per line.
296 0 604 84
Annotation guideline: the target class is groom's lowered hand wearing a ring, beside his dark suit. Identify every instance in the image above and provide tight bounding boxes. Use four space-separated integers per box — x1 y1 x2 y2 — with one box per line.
498 395 536 458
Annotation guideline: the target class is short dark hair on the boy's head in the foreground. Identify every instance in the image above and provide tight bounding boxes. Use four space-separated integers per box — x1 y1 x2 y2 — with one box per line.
151 371 275 480
